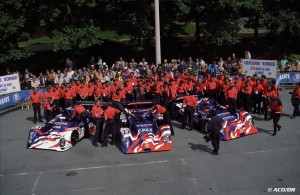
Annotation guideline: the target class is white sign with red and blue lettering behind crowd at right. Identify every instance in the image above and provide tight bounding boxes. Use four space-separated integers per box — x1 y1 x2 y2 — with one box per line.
243 59 277 79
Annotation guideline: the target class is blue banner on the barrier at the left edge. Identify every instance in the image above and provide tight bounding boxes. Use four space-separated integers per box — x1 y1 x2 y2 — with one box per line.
0 89 45 109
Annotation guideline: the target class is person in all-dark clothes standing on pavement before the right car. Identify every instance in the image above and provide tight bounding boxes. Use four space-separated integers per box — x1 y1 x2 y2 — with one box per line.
207 110 222 155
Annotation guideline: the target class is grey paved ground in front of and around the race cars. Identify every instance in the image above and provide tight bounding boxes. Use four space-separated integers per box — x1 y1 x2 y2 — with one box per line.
0 92 300 195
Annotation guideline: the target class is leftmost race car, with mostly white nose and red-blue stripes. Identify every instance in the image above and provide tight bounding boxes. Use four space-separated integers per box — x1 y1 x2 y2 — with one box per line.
27 108 95 151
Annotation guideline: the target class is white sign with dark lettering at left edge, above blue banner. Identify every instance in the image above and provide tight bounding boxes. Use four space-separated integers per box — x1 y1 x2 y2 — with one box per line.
0 74 21 95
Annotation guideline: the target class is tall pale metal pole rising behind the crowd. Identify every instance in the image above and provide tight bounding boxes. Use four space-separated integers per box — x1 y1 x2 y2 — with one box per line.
154 0 161 64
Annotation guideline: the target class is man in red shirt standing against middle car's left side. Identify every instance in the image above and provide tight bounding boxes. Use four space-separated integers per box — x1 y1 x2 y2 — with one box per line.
101 101 120 147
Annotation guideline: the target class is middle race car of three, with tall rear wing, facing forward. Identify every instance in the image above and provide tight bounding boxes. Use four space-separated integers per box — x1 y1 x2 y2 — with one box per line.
120 101 172 154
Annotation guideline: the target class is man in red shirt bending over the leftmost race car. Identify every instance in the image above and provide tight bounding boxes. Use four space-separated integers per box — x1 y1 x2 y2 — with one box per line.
70 102 91 138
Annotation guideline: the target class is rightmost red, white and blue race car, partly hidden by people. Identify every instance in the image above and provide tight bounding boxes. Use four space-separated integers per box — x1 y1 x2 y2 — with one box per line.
176 97 258 140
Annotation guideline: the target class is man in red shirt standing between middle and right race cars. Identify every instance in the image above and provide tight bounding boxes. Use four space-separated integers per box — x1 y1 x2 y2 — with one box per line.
180 91 198 131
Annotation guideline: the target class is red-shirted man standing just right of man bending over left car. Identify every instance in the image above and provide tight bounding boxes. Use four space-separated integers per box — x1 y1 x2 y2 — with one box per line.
92 99 104 147
